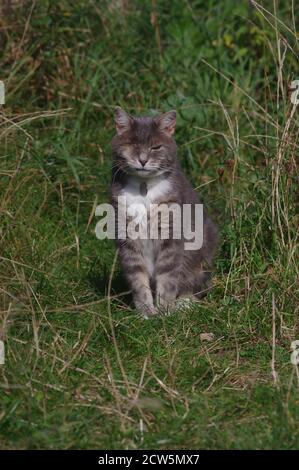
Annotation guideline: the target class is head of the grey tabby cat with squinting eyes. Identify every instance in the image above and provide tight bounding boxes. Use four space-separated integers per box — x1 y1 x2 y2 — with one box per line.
112 107 176 178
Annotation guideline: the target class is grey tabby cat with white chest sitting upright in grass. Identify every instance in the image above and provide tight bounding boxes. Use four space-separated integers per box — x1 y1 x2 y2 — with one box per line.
111 107 218 317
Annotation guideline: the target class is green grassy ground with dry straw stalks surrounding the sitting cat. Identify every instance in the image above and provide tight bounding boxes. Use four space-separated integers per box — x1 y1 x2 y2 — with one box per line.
0 0 299 449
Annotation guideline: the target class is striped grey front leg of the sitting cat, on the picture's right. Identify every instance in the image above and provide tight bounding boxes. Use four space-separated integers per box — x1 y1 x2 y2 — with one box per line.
155 240 183 310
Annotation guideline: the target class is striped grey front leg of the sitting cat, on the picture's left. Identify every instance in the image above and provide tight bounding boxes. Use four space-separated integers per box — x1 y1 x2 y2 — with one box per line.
119 239 157 317
